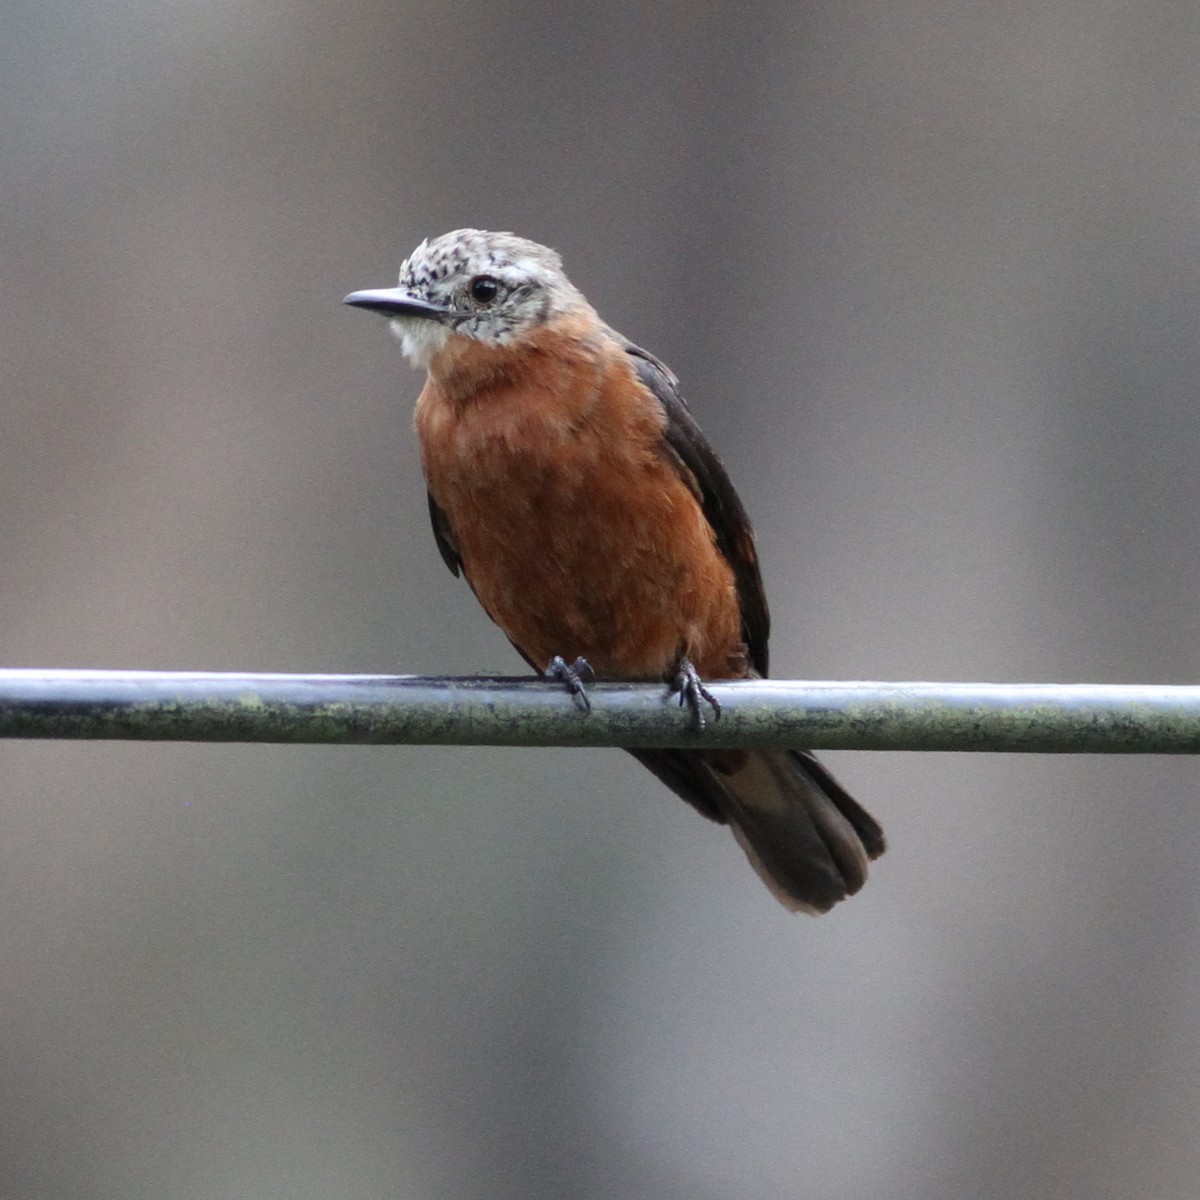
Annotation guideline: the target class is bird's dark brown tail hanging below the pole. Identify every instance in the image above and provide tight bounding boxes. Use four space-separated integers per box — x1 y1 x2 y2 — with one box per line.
630 750 887 913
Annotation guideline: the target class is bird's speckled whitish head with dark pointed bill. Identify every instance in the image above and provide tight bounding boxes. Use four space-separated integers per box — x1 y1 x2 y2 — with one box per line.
346 229 587 367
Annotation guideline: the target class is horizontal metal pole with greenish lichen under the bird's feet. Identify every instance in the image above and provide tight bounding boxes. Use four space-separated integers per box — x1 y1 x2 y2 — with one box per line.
0 670 1200 754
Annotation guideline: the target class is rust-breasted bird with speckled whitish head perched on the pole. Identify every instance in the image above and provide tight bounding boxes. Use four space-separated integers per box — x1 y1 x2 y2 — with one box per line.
344 229 886 914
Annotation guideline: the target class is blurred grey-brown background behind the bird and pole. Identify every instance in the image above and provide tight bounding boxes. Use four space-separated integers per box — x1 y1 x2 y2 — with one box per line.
0 0 1200 1200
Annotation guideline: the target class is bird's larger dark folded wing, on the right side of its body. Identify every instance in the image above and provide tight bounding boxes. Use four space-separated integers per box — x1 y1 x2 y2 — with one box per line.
624 342 770 676
